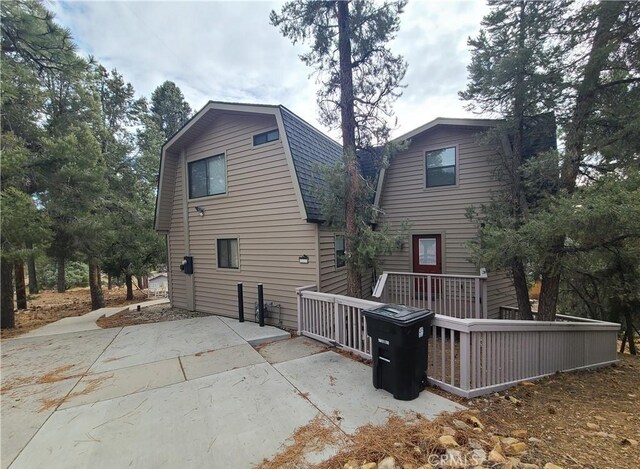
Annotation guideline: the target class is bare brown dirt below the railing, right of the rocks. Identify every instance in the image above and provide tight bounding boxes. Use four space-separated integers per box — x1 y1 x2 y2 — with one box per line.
458 354 640 469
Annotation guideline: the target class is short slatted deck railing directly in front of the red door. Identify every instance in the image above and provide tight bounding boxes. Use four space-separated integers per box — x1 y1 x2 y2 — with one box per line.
373 272 487 319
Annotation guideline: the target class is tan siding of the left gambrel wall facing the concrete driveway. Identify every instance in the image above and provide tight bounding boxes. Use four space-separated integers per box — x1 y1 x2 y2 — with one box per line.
171 113 318 328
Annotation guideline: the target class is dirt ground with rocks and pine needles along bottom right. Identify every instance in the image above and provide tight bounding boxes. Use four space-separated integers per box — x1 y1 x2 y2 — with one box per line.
261 355 640 469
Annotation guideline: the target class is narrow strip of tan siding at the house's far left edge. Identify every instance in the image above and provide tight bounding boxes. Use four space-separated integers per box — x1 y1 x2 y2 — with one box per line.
163 161 187 309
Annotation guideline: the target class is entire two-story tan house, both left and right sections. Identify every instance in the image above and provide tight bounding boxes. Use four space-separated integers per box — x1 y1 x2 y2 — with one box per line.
155 102 513 328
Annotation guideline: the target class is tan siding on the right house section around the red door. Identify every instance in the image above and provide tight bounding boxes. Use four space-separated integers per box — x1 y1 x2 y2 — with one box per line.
380 126 513 314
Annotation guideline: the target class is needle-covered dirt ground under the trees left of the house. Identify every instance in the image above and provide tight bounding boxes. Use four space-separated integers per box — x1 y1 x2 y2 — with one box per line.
2 288 147 339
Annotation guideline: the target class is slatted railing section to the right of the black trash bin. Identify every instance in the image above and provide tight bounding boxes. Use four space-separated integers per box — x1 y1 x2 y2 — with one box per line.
427 315 620 397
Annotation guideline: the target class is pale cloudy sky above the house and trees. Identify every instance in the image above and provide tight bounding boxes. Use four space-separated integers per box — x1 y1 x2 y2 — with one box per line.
48 0 487 137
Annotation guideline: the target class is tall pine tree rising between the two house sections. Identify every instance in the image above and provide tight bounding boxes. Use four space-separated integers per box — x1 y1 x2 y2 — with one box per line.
270 0 406 297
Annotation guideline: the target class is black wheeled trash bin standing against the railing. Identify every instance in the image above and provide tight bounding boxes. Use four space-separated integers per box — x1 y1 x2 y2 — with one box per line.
362 305 435 401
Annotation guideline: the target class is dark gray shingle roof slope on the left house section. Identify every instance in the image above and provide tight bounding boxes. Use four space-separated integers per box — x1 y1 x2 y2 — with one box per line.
280 106 342 221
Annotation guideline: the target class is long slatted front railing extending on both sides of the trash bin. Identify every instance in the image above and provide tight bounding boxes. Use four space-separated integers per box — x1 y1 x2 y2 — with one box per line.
297 286 620 397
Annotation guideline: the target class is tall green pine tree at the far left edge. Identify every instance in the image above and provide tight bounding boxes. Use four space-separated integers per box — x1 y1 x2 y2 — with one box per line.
0 1 80 327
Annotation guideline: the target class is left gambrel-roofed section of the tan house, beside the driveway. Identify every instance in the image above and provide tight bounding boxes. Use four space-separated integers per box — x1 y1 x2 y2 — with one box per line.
155 102 356 328
